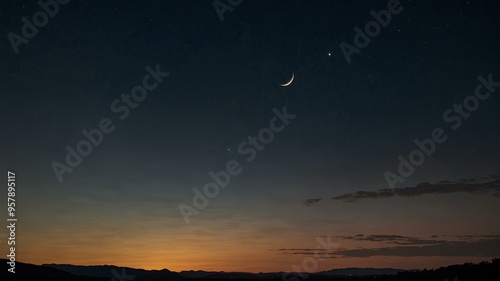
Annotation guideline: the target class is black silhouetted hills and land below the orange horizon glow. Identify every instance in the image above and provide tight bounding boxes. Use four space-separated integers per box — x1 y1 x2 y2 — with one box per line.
0 259 500 281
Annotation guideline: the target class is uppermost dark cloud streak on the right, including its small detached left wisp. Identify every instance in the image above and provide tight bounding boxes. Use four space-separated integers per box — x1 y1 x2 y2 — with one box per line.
304 174 500 203
